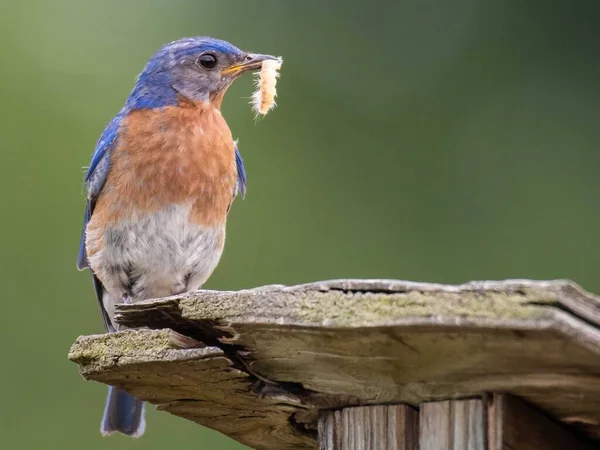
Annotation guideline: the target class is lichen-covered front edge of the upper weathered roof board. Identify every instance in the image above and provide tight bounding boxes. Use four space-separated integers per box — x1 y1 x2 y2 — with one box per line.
117 280 600 327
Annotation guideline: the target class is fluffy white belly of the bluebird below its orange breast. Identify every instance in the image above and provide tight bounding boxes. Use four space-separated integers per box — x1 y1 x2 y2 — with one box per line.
87 205 225 312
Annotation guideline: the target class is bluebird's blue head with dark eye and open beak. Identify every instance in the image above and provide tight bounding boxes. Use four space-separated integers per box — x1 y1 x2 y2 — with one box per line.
128 37 277 109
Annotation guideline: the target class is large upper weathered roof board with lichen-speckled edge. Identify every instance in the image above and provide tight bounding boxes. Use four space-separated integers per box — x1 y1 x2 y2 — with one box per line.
112 280 600 438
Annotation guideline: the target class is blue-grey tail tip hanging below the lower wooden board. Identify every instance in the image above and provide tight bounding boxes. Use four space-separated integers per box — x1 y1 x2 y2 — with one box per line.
100 386 146 437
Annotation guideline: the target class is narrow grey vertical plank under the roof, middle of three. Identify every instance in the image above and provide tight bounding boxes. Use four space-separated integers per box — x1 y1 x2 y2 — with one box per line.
419 399 487 450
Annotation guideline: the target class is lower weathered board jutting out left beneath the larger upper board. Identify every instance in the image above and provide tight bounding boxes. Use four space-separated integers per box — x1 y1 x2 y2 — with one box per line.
69 329 318 450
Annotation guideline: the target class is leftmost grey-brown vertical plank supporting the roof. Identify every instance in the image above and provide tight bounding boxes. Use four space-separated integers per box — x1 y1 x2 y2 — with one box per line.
319 405 419 450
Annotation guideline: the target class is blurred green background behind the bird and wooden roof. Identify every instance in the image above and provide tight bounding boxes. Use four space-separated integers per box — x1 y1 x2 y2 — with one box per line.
0 0 600 450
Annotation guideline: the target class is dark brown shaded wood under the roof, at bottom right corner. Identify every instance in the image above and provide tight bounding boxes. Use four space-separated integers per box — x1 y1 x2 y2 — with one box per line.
488 394 598 450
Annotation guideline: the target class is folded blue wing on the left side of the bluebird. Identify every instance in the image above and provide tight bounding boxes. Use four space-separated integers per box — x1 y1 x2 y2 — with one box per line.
77 113 124 331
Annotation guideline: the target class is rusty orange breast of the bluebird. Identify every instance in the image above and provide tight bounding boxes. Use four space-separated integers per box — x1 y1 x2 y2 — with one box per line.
92 104 236 227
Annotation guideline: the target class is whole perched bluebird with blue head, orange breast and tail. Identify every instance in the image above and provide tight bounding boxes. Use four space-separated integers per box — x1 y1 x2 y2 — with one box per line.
77 37 277 437
